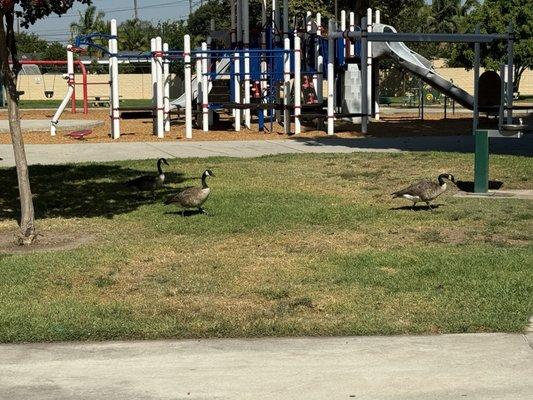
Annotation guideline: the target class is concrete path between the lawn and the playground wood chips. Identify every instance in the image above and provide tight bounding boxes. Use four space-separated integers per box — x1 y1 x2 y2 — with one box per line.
0 134 533 166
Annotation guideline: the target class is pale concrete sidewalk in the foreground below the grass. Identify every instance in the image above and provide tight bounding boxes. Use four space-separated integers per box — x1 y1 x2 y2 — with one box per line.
0 334 533 400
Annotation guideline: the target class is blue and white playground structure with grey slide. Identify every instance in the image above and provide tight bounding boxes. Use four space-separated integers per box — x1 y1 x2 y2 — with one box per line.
51 0 522 188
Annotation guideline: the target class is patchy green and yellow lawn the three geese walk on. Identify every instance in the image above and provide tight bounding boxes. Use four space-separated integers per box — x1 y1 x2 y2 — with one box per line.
0 153 533 342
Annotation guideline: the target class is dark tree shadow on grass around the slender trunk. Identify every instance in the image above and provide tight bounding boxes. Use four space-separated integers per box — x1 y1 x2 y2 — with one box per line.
0 164 190 220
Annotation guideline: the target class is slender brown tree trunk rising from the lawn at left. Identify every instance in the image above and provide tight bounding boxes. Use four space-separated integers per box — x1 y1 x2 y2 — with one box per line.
0 13 36 245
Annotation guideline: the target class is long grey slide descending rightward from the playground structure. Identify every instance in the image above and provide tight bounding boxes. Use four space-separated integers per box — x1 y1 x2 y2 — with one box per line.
372 24 474 110
